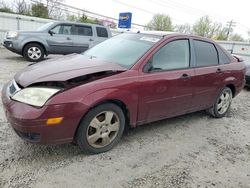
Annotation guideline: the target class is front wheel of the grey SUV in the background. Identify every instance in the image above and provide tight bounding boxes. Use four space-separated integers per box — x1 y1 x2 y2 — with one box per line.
23 43 44 62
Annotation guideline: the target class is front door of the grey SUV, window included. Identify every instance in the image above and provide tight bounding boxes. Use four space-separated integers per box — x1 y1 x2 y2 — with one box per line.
47 24 74 54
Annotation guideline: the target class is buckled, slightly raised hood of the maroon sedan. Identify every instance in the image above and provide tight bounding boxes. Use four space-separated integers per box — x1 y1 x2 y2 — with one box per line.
15 54 127 87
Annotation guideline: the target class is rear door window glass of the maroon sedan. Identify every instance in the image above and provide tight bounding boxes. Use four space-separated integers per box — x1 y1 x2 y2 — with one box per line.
194 40 219 67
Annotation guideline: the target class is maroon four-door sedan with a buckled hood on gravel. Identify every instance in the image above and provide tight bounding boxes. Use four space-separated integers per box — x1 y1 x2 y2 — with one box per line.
2 33 245 153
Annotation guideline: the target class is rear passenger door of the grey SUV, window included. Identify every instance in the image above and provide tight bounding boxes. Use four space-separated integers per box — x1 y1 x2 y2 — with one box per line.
72 24 94 53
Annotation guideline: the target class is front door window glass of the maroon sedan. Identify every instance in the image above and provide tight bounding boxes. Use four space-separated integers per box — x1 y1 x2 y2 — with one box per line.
151 39 190 70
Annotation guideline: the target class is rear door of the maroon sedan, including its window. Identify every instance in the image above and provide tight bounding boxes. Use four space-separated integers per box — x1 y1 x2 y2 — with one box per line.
192 39 224 110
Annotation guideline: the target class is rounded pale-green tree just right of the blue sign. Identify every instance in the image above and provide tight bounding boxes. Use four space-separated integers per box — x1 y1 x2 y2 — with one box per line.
146 14 173 31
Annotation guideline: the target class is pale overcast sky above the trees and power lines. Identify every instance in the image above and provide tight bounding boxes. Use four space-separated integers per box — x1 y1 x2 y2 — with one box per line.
65 0 250 38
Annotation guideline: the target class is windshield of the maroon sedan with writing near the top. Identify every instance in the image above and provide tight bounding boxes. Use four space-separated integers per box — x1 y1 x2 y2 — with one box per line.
84 33 161 68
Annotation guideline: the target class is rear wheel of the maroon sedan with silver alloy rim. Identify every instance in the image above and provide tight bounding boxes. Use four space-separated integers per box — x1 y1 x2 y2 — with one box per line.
208 87 233 118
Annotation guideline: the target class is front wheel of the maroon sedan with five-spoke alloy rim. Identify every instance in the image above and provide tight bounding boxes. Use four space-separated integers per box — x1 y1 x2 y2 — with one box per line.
76 103 125 154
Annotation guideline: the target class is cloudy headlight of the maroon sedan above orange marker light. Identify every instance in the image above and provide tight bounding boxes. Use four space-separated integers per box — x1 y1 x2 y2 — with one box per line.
12 87 60 107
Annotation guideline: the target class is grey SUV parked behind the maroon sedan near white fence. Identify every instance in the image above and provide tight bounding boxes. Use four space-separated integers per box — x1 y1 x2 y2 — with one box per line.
3 22 111 62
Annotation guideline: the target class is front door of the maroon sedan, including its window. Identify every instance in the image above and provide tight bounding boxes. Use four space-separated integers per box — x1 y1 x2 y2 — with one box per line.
138 39 194 123
